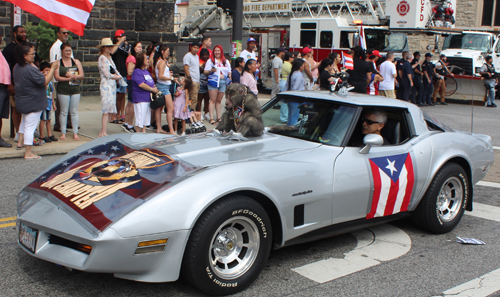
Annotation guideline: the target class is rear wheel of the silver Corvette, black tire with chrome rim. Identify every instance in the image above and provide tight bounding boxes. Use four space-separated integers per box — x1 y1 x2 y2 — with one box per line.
412 163 470 234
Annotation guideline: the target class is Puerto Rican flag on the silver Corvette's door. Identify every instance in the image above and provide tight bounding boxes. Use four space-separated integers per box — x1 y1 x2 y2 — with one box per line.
366 153 415 219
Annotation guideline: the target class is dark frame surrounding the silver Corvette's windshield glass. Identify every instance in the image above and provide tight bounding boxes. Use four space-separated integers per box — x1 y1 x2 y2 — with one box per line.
262 93 361 147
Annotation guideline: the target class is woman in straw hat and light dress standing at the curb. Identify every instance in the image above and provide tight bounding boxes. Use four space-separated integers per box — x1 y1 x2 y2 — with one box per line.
97 38 122 137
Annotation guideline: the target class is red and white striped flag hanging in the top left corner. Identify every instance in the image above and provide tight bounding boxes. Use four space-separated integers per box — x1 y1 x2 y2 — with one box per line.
5 0 95 36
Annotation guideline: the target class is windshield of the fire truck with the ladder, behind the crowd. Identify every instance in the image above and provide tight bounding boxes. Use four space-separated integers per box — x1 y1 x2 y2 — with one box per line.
364 29 406 52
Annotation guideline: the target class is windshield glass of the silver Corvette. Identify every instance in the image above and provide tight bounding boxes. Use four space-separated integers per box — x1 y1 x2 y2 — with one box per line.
262 94 357 146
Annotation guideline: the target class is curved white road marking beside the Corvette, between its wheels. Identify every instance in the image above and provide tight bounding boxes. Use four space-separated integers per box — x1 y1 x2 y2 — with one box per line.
292 224 411 283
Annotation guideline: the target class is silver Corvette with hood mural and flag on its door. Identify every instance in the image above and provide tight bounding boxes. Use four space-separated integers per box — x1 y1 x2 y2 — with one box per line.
17 92 493 295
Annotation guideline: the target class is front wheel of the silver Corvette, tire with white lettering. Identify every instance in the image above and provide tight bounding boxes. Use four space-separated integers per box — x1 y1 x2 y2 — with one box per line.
181 195 272 295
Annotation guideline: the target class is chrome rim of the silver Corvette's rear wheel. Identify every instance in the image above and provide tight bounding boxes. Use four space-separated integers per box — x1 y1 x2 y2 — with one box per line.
436 177 464 222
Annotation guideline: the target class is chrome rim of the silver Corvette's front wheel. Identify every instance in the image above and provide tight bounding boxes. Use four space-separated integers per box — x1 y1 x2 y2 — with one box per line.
208 217 260 279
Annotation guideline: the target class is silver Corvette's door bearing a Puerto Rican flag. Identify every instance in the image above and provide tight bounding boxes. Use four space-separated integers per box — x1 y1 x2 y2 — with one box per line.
332 107 431 224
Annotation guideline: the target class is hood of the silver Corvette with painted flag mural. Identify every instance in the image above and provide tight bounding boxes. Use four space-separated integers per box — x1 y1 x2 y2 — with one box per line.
27 134 318 232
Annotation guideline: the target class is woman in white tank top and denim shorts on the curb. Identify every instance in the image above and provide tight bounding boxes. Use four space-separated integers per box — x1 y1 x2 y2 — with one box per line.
155 44 177 135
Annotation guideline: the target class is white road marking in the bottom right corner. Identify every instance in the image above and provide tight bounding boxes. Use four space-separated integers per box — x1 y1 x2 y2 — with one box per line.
439 269 500 297
